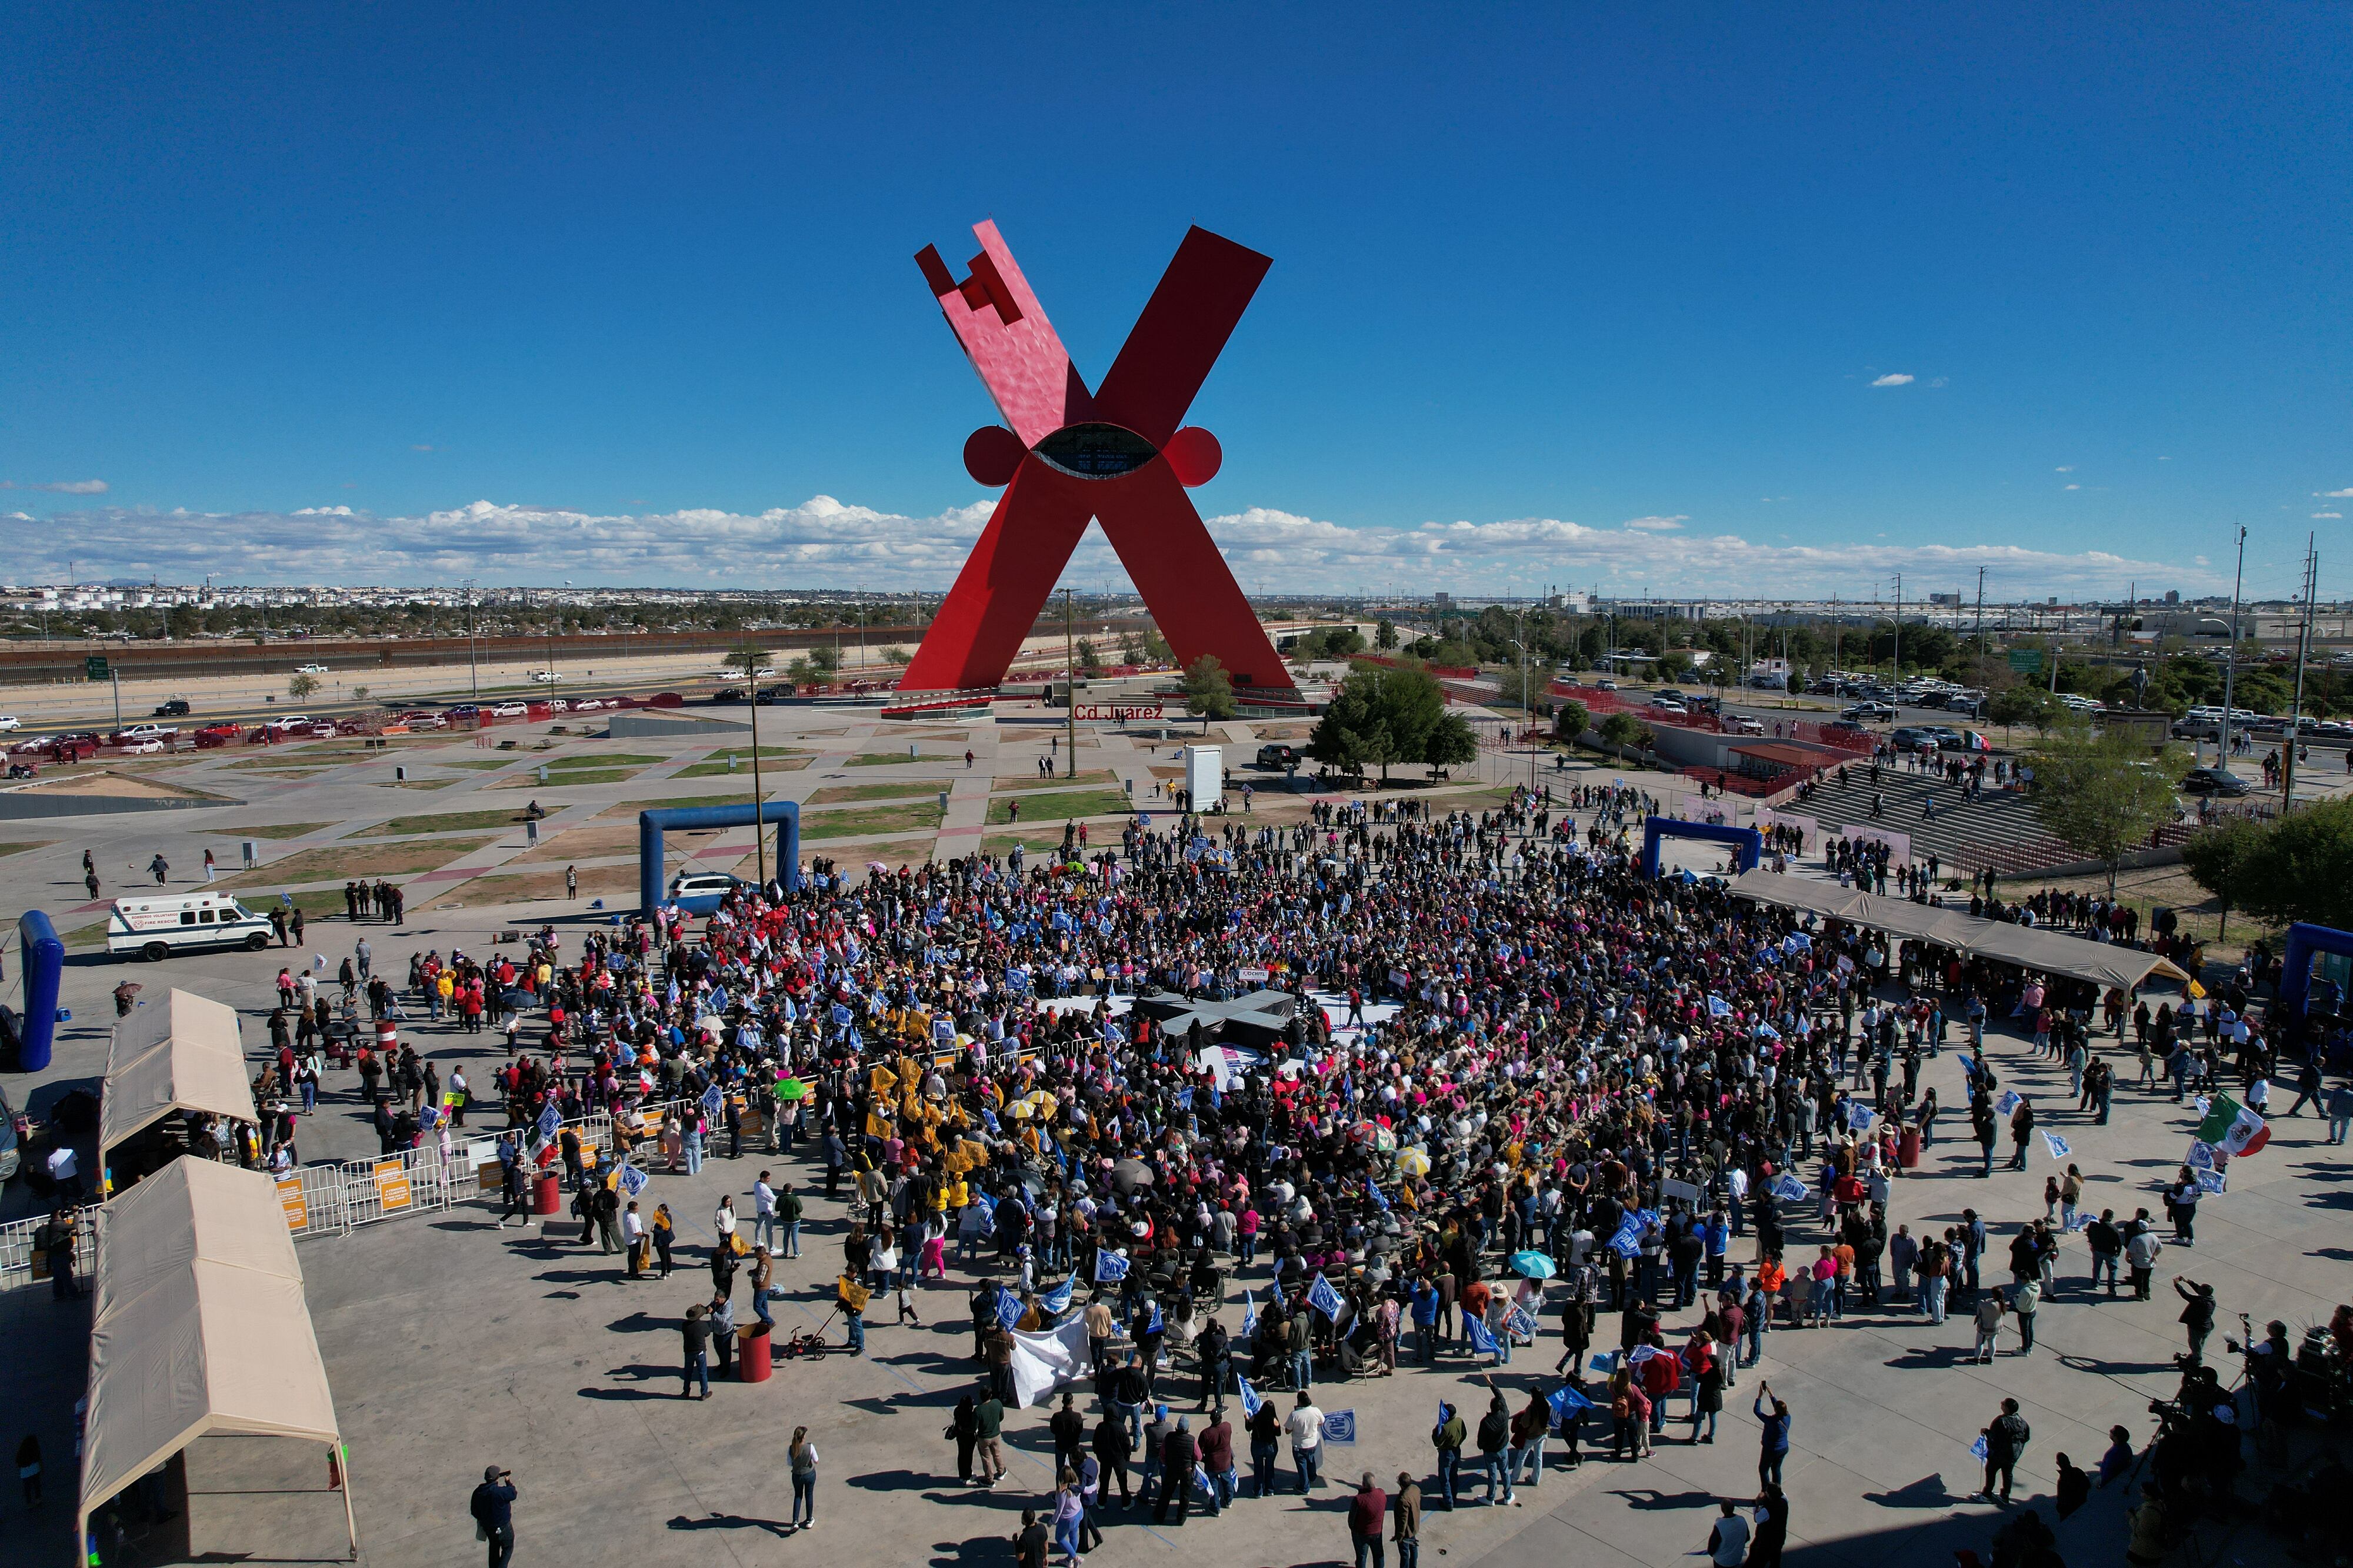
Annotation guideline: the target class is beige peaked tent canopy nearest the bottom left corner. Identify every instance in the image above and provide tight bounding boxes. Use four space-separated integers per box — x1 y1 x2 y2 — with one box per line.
75 1160 360 1561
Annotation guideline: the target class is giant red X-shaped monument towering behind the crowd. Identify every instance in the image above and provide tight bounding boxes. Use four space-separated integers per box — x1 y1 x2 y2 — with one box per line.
899 223 1292 692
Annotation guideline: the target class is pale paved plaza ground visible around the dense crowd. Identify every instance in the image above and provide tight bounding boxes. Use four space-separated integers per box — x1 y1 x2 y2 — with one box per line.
0 709 2353 1568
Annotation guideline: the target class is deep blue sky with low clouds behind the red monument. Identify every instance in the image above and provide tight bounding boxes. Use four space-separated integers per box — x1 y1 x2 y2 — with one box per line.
0 5 2353 598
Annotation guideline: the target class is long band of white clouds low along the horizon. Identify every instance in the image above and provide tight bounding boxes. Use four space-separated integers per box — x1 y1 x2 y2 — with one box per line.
16 495 2228 598
